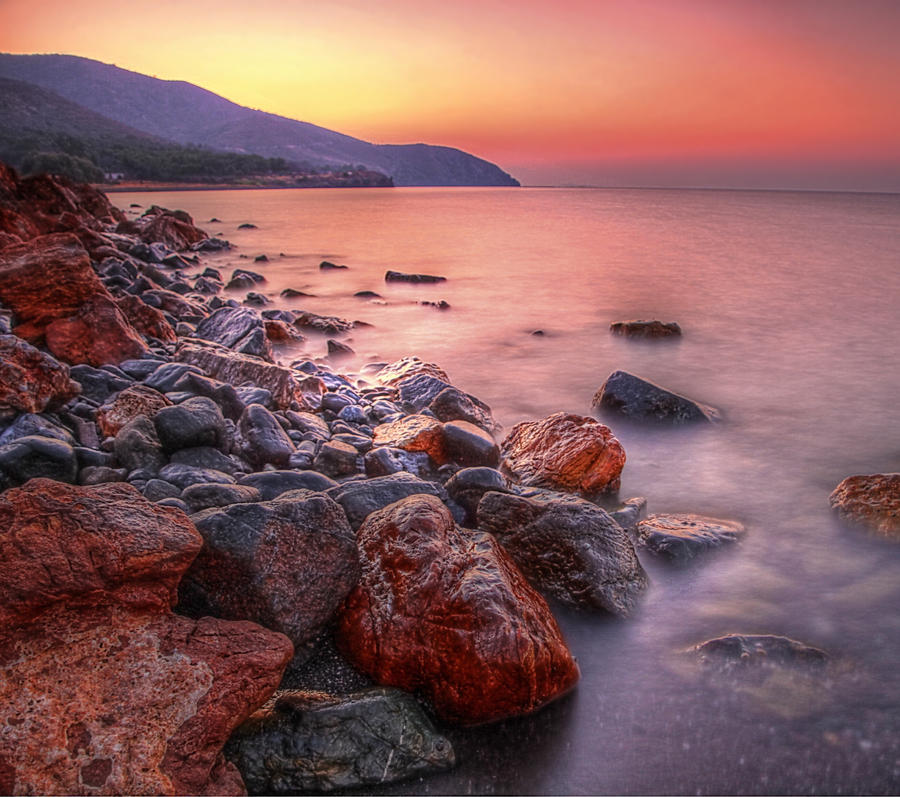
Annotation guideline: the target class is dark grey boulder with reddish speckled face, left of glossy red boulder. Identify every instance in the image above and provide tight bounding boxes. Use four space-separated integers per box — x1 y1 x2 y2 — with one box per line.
182 492 359 645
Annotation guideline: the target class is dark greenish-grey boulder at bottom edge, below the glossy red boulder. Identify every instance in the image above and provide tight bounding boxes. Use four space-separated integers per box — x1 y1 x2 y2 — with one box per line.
226 689 455 794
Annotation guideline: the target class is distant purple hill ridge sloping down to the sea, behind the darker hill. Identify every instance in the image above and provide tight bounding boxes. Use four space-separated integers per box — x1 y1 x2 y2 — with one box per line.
0 54 518 186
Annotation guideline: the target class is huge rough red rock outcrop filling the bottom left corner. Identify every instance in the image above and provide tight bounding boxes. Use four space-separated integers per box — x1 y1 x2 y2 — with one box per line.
0 479 292 794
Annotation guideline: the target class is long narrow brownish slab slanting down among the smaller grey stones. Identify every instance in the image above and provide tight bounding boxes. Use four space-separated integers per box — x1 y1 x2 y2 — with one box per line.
175 342 325 410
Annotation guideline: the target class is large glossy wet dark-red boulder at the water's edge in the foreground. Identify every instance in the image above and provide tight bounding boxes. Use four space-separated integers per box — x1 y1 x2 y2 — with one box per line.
338 495 578 725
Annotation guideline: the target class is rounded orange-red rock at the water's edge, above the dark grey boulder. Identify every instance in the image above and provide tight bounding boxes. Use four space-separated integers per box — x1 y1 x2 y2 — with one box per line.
501 412 625 495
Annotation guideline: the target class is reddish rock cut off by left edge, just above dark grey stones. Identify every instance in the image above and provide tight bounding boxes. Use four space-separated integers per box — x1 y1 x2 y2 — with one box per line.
0 335 81 412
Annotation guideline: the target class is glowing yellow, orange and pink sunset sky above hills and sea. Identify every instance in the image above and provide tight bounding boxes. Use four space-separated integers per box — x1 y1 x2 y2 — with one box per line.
0 0 900 191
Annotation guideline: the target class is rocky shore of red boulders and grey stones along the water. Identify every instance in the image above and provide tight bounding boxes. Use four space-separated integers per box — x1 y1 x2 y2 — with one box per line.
0 164 896 794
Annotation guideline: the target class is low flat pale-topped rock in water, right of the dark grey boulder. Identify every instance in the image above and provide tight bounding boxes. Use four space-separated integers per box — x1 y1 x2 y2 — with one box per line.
635 514 745 561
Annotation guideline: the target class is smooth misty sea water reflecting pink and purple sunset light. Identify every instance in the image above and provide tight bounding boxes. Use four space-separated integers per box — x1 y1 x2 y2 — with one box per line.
113 189 900 794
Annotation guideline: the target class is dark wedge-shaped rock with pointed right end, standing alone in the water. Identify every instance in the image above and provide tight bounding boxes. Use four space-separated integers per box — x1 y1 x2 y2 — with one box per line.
591 371 720 423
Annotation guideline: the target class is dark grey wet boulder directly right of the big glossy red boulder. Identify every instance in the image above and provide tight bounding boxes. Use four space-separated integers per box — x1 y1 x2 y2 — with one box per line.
477 491 648 617
